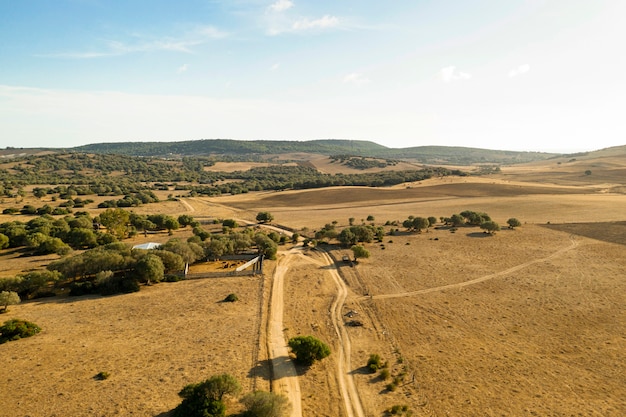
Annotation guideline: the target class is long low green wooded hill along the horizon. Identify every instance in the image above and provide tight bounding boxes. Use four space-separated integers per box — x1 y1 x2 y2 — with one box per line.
70 139 557 165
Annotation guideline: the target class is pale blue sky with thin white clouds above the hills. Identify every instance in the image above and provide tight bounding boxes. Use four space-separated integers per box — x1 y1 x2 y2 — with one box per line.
0 0 626 152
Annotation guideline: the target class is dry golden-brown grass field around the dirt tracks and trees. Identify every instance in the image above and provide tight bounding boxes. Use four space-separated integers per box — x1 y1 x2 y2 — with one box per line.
0 150 626 417
